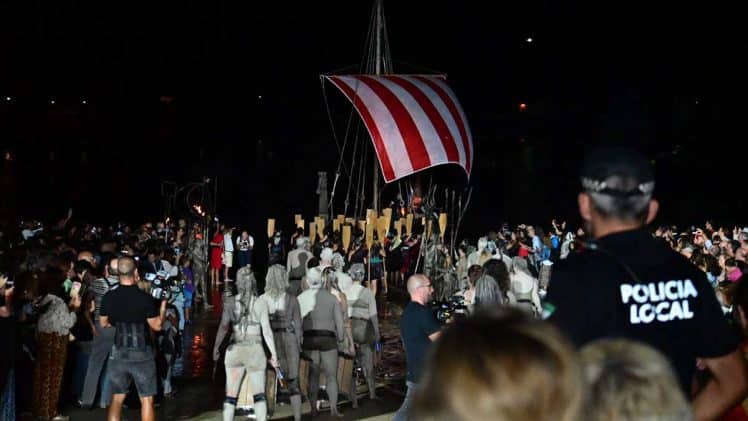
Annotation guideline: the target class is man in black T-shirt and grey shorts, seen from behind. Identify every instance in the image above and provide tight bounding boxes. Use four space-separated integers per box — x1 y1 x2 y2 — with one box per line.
99 257 167 421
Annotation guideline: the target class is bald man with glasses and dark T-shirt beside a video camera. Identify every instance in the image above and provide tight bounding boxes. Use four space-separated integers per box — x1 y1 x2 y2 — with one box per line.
393 274 441 421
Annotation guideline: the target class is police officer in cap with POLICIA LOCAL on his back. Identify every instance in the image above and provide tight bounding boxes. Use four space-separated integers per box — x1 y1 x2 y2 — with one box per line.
543 147 748 419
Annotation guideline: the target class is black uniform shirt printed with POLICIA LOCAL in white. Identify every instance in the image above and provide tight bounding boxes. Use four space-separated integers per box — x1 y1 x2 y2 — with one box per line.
544 229 739 396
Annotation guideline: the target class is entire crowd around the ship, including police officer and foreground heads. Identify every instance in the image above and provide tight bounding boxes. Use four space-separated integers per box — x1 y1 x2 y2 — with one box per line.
0 145 748 421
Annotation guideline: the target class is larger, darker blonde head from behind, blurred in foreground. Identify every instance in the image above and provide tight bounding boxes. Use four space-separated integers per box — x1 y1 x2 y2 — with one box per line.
413 308 583 421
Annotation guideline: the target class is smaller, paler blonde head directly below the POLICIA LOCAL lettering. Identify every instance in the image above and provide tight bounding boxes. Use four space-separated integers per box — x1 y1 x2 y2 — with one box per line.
580 339 693 421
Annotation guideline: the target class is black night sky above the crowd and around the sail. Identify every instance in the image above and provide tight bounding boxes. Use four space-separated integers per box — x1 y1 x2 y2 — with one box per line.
0 0 748 236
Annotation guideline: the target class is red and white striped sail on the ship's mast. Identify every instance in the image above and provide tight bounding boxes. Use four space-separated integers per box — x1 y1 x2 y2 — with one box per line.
326 75 473 183
